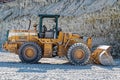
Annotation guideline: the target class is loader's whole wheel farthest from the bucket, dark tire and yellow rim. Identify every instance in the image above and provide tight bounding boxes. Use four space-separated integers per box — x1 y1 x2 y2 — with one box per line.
18 42 42 63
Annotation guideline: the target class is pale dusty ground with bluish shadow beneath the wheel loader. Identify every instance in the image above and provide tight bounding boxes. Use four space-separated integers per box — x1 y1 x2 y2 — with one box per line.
0 52 120 80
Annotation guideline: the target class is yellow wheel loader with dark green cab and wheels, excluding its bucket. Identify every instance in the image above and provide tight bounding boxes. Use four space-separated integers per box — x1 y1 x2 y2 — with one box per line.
3 14 114 65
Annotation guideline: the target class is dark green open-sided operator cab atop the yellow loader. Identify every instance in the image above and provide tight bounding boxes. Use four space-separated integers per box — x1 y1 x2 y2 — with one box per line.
38 14 62 39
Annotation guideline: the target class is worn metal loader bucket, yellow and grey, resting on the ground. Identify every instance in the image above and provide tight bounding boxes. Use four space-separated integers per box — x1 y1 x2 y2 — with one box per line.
90 45 115 65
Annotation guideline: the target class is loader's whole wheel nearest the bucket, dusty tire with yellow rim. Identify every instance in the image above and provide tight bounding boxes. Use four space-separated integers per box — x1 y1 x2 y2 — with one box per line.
67 43 91 65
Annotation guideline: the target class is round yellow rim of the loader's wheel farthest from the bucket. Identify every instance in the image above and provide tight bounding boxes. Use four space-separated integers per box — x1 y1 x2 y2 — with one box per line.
24 47 35 58
